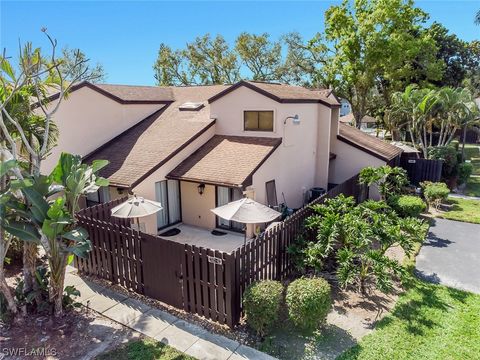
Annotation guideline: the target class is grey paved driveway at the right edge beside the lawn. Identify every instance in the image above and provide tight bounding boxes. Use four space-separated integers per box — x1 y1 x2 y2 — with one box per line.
416 219 480 294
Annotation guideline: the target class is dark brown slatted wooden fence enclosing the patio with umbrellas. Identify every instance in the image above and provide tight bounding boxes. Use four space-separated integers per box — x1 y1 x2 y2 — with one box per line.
75 175 367 327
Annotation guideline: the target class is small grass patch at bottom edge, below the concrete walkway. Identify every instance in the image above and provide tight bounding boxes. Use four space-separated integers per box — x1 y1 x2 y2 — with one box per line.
96 339 195 360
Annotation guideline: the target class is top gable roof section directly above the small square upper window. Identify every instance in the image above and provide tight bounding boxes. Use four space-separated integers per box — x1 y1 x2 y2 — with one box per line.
208 81 340 107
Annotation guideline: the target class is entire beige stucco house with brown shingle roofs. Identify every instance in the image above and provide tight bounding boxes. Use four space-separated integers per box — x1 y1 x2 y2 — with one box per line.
44 81 401 233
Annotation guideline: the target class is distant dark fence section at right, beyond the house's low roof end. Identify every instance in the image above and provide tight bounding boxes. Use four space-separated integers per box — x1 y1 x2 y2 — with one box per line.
400 158 443 186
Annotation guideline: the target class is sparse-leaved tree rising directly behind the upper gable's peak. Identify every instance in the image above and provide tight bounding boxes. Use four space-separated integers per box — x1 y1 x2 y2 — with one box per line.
235 32 283 81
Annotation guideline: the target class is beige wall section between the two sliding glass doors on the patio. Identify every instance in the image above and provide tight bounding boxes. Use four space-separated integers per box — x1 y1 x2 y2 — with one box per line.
180 181 215 229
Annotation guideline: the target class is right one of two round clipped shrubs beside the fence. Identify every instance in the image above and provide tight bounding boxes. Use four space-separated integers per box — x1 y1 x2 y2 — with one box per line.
286 278 332 332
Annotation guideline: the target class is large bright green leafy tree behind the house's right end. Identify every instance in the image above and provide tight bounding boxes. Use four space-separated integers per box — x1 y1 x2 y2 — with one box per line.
310 0 439 127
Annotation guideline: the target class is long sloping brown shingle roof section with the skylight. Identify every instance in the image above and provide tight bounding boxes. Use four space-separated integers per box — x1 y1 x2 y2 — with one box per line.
85 85 230 187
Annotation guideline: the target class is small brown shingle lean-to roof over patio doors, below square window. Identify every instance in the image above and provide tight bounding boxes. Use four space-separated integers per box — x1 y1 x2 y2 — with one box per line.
167 135 282 186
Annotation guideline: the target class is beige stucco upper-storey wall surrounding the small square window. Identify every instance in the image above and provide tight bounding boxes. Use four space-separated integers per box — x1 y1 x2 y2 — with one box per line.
211 87 330 207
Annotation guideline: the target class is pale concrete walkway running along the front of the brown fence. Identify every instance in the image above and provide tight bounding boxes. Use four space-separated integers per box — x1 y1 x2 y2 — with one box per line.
65 267 275 360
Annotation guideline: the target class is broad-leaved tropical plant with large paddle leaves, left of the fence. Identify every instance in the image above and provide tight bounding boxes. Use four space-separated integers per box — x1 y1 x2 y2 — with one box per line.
2 153 108 316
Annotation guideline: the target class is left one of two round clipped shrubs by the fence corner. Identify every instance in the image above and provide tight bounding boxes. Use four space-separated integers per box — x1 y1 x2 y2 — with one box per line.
243 280 283 336
